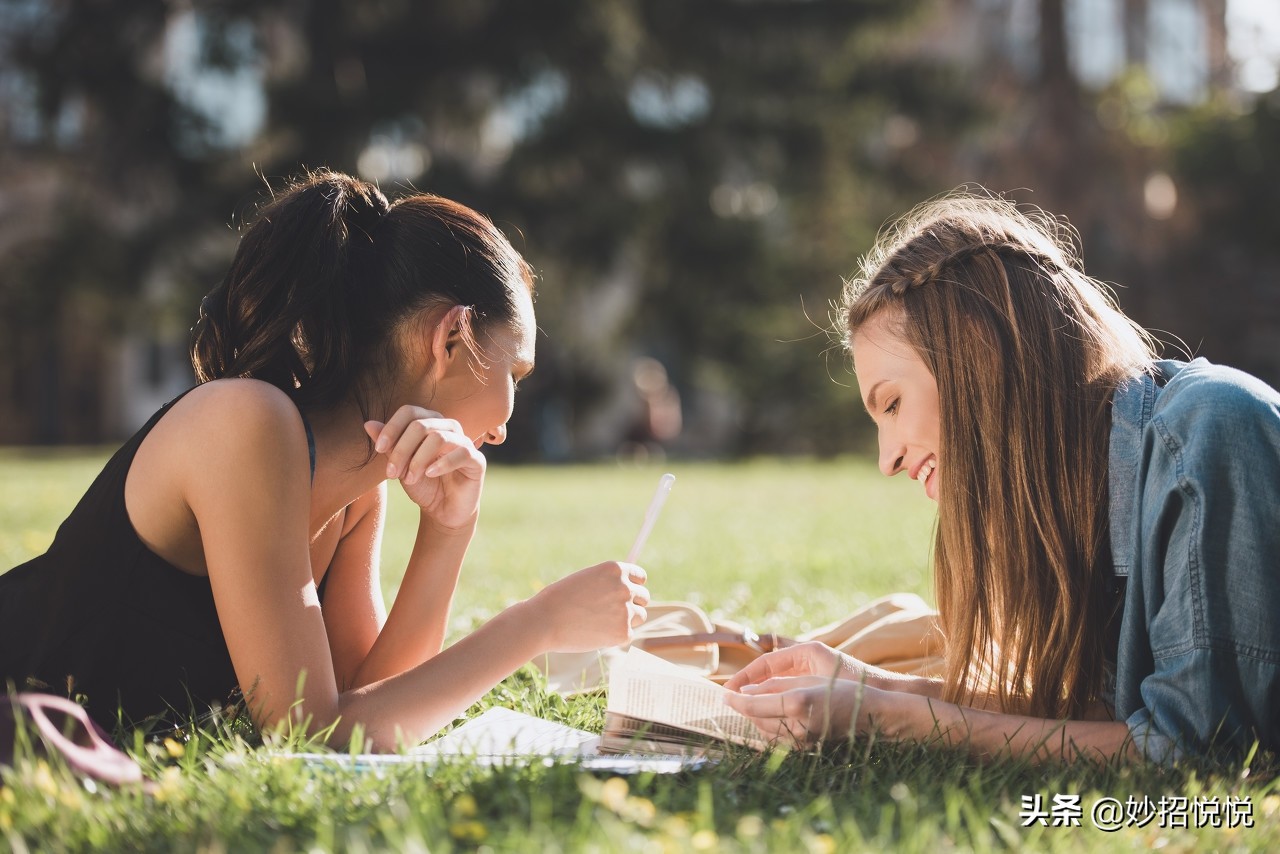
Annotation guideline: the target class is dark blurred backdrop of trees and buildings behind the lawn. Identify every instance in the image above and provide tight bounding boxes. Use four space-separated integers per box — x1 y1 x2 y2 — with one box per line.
0 0 1280 460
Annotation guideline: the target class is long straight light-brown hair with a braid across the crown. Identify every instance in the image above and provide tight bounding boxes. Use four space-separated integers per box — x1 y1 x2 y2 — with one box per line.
841 195 1155 718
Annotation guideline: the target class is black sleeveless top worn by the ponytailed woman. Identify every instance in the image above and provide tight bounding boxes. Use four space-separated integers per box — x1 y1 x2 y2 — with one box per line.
0 396 324 731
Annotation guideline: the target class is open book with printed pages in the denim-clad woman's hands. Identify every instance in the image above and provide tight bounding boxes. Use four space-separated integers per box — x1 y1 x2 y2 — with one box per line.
600 648 768 757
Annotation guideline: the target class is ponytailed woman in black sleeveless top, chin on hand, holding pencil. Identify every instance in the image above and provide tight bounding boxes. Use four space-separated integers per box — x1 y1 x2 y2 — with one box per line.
0 172 648 750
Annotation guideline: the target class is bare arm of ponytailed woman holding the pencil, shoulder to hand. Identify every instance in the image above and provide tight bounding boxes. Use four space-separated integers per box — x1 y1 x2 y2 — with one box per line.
182 384 648 750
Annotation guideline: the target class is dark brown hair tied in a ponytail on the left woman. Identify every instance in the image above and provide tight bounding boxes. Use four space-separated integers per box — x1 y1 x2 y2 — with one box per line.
191 170 532 408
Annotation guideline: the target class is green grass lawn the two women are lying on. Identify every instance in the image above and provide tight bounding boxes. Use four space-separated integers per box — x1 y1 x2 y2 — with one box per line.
0 451 1280 851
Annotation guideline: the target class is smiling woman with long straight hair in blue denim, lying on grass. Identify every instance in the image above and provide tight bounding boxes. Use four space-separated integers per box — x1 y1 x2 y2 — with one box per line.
728 196 1280 761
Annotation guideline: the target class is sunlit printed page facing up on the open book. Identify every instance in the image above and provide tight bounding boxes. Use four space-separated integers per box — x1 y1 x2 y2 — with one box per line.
605 648 768 750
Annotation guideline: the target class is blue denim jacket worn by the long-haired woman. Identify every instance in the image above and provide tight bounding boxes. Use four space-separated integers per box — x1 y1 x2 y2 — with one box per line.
1108 359 1280 762
